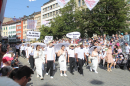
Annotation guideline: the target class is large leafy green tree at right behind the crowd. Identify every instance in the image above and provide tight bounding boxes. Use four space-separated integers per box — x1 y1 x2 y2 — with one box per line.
80 0 129 35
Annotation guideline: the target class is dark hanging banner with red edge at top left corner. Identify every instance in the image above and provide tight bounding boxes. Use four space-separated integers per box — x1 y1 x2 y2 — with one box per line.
0 0 7 28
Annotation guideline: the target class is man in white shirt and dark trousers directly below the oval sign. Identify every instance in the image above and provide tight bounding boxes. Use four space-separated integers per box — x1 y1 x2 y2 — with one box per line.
68 45 75 75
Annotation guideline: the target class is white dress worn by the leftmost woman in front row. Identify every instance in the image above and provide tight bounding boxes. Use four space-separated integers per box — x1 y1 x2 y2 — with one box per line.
34 51 45 77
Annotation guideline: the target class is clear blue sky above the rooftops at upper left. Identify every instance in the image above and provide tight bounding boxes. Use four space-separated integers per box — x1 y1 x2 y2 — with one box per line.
4 0 49 18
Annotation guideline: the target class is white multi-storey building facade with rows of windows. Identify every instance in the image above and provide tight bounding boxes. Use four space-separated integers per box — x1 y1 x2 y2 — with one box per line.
41 1 60 25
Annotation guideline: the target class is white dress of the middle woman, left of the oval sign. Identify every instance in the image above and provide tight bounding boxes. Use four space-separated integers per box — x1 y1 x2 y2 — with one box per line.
59 52 66 71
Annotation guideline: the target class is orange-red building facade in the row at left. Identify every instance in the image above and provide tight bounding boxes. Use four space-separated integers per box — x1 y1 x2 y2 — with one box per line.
16 21 23 41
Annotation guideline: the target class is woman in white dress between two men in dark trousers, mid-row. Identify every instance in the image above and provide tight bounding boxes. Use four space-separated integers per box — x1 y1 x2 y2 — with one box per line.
58 45 67 76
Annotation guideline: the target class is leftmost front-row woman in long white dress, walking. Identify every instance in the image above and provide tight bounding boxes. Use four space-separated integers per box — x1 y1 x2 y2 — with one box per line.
34 45 45 80
